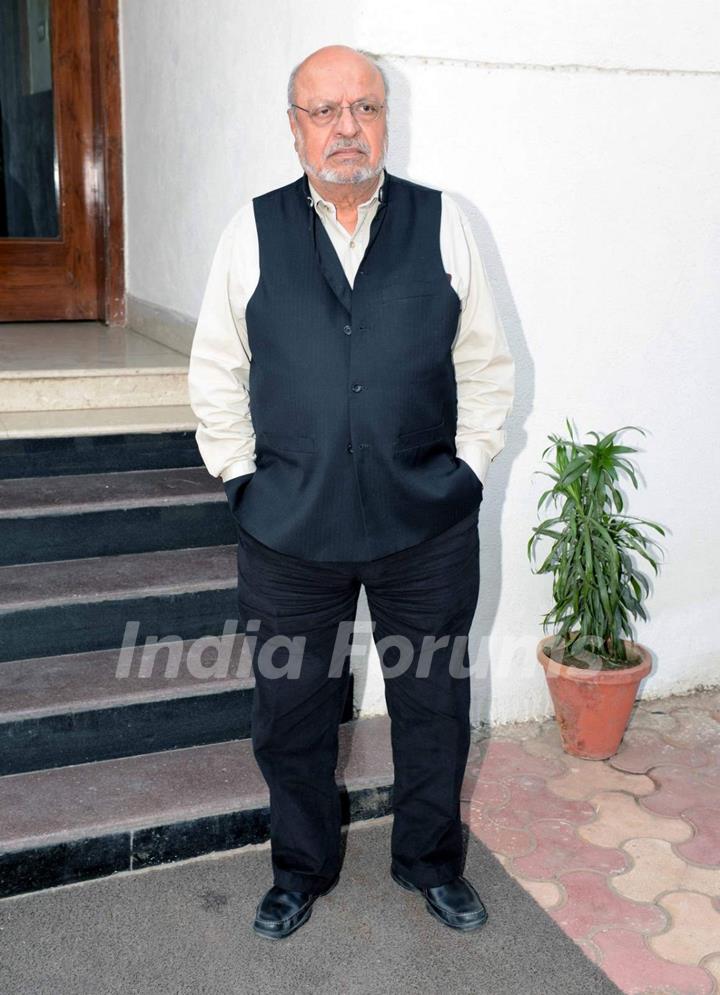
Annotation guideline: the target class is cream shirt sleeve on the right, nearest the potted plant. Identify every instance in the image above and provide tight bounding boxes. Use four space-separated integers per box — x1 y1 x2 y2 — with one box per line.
441 191 515 483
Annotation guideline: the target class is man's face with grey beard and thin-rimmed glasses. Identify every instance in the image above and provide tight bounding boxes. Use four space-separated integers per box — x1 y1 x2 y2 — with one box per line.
288 57 388 183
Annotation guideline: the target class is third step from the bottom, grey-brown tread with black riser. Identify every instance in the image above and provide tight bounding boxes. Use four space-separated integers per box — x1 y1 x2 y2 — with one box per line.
0 543 237 661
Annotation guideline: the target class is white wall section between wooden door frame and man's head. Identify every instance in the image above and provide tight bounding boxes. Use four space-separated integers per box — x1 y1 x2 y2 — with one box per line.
120 0 352 317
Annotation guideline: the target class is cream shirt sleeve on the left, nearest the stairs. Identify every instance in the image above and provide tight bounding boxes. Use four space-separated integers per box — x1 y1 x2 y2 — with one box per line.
188 202 259 481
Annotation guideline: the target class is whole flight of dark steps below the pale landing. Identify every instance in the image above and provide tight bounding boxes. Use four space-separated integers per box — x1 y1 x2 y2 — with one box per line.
0 428 393 897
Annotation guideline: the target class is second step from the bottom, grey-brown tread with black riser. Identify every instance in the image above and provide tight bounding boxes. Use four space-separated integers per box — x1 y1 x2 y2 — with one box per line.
0 632 353 775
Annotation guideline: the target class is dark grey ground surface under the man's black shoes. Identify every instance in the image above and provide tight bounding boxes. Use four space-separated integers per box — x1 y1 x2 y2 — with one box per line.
0 817 619 995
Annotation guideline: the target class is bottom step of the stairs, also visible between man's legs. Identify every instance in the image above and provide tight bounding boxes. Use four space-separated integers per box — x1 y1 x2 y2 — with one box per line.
0 716 393 897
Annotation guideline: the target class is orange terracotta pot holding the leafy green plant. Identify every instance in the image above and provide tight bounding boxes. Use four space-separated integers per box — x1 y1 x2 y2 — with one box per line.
537 636 652 760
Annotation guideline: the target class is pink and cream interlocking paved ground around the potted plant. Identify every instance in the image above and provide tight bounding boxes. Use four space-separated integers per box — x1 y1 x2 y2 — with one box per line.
463 689 720 995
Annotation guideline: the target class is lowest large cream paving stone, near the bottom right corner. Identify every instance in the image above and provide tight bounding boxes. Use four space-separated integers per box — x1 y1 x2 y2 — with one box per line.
648 891 720 965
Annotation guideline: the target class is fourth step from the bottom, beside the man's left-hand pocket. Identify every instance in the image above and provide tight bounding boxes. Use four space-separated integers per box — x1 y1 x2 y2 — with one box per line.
0 467 237 566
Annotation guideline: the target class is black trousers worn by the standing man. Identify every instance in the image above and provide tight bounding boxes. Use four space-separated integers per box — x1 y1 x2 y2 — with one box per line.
238 512 479 892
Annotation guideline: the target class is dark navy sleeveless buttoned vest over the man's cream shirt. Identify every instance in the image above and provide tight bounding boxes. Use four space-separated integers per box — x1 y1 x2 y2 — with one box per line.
235 171 483 561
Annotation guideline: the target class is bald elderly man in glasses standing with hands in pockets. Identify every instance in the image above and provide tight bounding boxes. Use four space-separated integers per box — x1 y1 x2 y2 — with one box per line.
189 45 514 939
